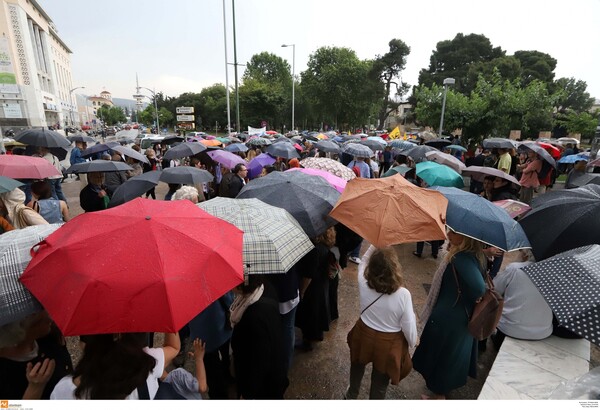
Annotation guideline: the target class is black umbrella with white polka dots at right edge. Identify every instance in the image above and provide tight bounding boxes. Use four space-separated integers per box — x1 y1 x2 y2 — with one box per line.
522 244 600 346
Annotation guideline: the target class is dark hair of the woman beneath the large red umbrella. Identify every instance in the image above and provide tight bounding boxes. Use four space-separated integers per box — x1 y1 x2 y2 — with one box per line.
73 333 156 400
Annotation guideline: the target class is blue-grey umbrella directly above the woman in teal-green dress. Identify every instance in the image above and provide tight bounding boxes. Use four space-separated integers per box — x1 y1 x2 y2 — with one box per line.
433 187 531 252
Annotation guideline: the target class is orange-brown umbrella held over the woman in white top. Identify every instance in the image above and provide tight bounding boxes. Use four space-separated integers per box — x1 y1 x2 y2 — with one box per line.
330 174 448 247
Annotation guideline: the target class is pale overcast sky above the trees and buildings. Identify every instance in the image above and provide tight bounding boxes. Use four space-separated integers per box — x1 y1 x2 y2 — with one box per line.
38 0 600 99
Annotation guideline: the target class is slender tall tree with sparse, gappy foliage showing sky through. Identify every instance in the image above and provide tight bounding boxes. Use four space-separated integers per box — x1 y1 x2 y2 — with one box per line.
370 39 410 130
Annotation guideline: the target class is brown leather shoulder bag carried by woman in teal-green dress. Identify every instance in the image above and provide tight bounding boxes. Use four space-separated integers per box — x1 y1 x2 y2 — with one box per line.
452 264 504 340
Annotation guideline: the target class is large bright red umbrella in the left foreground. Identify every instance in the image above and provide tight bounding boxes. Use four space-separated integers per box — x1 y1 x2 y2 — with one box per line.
20 198 243 336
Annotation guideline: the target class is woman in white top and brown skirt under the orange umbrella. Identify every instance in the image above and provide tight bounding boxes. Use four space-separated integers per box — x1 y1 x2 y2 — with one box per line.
345 246 417 399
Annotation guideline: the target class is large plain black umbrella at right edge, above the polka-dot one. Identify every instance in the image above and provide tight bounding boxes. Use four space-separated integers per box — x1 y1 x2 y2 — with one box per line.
519 185 600 260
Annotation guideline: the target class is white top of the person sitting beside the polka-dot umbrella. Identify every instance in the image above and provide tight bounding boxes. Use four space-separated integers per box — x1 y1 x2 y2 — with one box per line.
494 262 552 340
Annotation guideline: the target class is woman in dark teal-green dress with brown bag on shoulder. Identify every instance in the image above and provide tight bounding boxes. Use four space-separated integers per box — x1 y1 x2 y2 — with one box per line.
413 231 486 399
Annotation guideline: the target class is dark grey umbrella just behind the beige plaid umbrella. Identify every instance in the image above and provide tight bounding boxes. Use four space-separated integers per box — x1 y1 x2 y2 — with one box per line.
237 172 340 238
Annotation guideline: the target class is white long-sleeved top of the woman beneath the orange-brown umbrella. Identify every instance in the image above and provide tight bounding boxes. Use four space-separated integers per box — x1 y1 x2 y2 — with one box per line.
358 245 417 347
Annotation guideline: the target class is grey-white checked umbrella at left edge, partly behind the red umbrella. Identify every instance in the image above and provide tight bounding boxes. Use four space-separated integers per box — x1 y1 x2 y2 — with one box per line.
0 224 60 326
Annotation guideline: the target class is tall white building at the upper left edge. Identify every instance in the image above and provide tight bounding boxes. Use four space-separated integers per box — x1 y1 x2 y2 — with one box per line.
0 0 79 131
